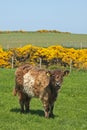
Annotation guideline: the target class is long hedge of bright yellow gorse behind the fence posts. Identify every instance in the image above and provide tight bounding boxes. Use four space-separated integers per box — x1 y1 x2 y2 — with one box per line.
0 45 87 69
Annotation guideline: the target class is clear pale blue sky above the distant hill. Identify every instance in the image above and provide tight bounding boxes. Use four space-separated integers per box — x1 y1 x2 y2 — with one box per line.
0 0 87 34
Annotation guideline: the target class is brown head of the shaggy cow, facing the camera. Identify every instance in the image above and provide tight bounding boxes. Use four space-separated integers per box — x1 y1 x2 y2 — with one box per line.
49 70 69 91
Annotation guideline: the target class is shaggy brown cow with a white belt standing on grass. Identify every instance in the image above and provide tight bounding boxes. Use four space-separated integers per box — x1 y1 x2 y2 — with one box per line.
13 64 69 118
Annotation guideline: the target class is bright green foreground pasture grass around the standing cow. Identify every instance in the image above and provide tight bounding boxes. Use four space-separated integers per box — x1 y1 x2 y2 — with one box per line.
0 69 87 130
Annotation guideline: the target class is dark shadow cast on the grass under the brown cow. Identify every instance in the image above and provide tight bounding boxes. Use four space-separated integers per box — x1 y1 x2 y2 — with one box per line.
10 108 44 117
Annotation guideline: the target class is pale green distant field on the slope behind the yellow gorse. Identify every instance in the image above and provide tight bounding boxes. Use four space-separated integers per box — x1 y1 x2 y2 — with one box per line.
0 32 87 49
